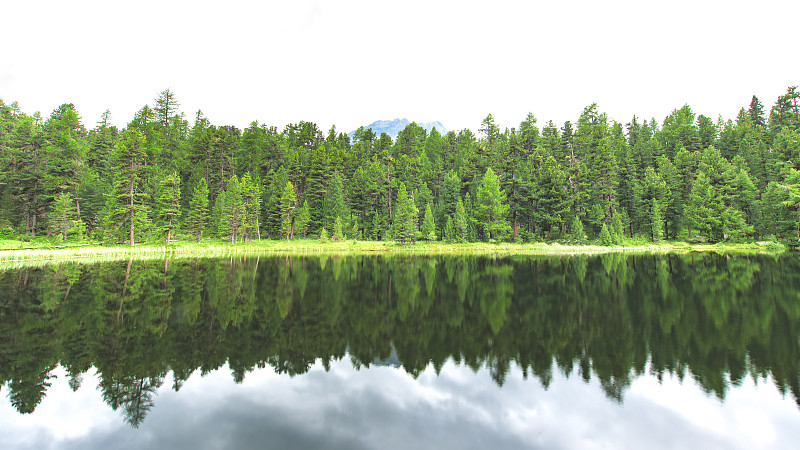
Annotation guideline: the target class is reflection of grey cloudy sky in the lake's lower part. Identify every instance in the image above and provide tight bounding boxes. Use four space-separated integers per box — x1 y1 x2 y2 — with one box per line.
0 359 800 450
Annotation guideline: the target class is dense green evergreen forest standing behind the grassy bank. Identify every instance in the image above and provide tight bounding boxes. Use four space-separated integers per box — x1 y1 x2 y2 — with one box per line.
0 87 800 245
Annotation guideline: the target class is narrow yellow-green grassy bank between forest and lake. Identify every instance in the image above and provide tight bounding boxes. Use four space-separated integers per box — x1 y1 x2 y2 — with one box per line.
0 239 785 265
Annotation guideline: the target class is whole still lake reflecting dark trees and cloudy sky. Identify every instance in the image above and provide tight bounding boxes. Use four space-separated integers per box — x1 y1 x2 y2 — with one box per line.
0 254 800 448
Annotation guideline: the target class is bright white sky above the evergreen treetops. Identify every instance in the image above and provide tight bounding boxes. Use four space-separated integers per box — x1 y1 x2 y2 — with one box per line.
0 0 800 132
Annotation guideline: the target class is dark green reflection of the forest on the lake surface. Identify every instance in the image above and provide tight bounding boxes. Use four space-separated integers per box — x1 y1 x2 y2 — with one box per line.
0 254 800 427
